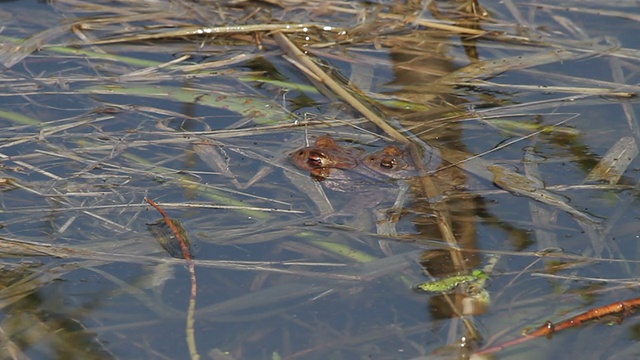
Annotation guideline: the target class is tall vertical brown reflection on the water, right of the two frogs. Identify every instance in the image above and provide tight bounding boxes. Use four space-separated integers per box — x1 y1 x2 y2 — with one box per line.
391 38 484 326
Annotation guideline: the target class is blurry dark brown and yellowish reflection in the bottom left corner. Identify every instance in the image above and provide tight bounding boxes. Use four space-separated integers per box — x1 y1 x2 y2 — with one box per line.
0 264 114 359
